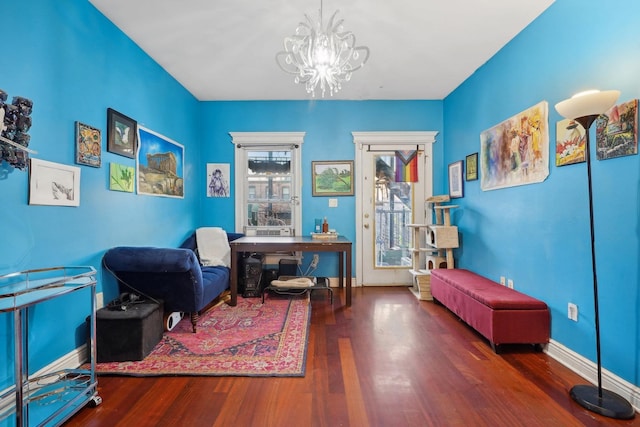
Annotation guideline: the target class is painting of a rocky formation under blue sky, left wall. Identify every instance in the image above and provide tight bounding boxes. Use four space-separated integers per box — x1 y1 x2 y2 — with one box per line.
136 126 184 199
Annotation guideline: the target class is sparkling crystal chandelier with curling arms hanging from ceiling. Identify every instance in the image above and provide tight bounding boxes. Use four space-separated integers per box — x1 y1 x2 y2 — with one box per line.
276 0 369 98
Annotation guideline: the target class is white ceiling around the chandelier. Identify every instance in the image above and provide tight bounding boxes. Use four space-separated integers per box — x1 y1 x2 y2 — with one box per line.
89 0 554 100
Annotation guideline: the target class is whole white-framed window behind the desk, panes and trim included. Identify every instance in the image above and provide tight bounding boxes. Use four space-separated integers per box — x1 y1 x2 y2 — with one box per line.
231 132 304 235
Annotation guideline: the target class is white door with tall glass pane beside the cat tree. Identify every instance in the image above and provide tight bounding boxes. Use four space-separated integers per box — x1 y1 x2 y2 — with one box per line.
354 132 435 286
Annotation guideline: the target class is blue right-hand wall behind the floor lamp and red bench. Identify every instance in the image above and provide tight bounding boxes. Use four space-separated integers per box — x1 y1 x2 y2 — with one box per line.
444 0 640 384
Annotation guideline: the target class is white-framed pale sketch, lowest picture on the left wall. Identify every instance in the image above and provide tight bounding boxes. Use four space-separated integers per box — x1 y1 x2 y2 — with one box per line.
29 158 80 206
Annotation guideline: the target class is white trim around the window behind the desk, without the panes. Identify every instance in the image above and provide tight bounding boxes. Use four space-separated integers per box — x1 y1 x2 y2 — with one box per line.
229 132 306 235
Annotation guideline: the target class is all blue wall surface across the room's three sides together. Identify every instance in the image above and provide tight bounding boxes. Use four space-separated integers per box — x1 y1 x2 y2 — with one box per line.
0 0 640 398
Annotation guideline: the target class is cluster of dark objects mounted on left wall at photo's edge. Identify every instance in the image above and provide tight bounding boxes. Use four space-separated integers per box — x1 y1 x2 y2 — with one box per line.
0 89 34 170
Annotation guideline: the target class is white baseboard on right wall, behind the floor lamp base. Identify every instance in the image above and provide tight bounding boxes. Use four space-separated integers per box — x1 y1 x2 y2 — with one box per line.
544 340 640 412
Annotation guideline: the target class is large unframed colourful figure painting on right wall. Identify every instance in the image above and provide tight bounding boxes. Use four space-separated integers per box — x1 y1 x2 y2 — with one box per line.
480 101 549 191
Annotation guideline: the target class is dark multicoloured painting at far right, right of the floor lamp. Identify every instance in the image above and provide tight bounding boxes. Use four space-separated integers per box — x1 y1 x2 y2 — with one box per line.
596 99 638 160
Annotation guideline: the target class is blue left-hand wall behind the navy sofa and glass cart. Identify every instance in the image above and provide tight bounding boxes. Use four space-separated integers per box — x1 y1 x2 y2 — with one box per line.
0 0 200 382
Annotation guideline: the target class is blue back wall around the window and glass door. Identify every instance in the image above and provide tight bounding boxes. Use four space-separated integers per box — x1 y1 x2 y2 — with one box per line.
201 101 443 277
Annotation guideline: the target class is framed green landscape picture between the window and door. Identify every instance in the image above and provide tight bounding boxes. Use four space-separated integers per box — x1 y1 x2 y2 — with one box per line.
311 160 353 196
